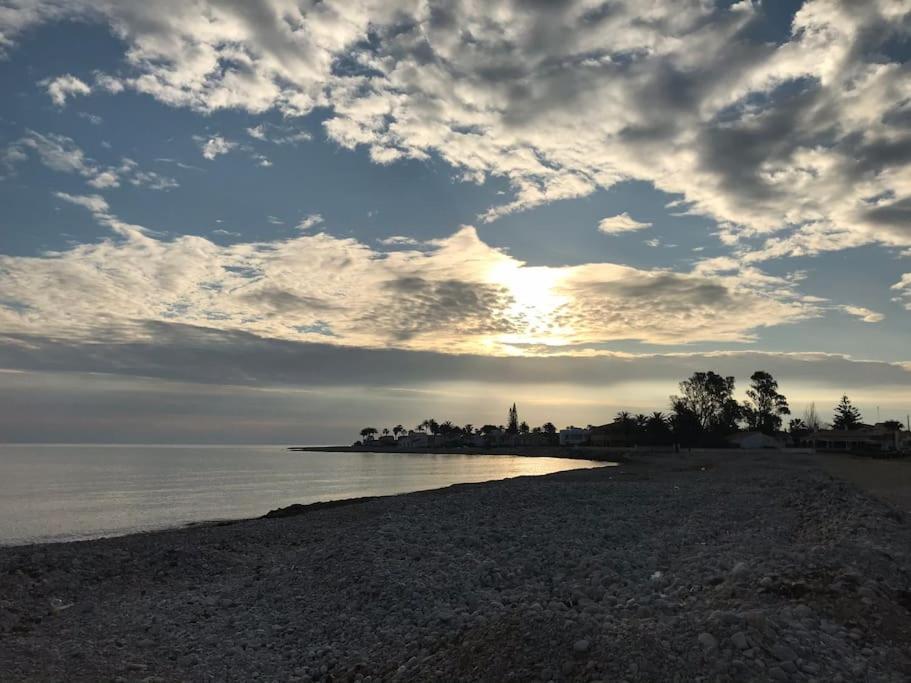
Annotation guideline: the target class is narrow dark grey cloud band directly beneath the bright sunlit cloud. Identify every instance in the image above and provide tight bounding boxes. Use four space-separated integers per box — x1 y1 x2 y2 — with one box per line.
0 323 911 391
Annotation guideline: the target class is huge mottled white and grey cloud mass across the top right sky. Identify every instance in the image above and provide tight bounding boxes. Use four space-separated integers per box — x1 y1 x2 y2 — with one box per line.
0 0 911 261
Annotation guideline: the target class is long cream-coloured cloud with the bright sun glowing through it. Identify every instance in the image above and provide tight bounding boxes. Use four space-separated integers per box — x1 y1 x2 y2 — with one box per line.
0 193 825 355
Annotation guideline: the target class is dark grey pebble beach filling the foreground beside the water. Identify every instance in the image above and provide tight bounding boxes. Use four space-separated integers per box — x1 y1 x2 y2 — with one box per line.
0 454 911 682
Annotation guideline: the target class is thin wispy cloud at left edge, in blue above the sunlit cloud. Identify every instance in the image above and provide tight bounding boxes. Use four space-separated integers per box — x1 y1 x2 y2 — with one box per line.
0 130 178 190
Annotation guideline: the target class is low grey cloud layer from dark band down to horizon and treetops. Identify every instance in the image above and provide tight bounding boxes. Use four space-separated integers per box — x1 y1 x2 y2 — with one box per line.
7 342 911 444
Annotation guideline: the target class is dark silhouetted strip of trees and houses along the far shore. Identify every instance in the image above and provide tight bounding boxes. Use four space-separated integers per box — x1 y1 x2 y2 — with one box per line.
352 370 911 455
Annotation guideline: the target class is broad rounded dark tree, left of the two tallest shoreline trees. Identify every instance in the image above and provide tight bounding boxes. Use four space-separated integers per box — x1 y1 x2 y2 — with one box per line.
671 370 741 435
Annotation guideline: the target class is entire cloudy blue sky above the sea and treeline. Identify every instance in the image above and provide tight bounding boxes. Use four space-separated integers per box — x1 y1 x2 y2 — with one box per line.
0 0 911 444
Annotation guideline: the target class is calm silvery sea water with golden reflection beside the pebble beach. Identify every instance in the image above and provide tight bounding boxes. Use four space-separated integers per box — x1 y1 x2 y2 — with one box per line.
0 445 603 544
